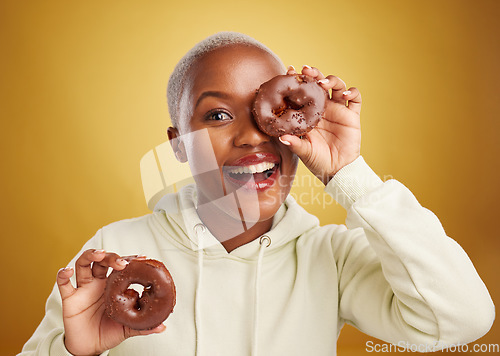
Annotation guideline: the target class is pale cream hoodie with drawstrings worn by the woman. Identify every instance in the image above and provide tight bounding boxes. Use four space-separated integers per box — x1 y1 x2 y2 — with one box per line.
21 157 494 356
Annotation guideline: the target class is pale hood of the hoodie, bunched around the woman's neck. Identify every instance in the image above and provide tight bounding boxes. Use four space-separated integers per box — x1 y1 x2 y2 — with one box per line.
154 184 319 260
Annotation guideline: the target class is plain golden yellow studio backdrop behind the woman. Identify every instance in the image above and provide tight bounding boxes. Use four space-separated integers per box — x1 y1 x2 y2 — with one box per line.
0 0 500 355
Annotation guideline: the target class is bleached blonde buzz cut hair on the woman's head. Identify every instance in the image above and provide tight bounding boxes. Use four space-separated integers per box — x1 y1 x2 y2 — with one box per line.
167 32 285 128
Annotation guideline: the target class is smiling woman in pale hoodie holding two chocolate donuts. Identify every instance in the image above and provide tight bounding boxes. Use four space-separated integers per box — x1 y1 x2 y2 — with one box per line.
23 33 494 356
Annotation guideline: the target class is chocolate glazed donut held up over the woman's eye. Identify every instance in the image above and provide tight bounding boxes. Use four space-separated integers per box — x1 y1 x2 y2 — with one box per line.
253 74 328 137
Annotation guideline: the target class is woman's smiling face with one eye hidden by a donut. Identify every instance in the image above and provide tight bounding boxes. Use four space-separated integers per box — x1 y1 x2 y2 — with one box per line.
172 45 298 222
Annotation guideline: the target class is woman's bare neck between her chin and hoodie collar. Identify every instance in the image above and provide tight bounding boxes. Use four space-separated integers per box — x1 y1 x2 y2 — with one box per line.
196 203 273 252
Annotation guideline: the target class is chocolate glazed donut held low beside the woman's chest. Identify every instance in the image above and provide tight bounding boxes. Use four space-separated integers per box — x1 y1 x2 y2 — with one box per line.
104 259 175 330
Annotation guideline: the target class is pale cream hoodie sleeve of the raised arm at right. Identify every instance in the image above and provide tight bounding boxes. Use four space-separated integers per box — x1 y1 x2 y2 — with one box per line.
325 157 495 350
